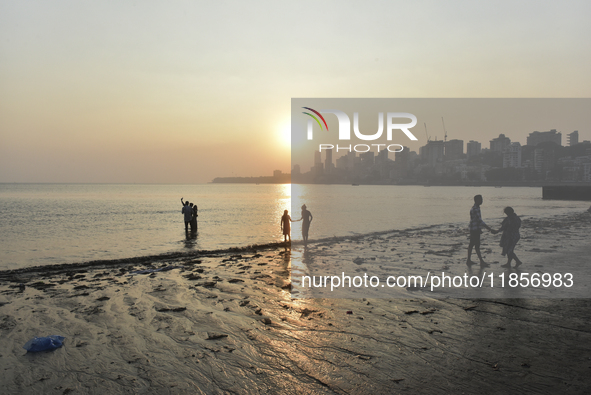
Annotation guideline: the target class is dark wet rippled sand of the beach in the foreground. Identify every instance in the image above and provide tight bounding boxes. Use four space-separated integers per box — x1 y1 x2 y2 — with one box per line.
0 214 591 394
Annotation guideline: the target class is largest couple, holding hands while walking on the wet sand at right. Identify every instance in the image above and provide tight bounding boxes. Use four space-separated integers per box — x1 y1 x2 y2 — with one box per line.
466 195 521 268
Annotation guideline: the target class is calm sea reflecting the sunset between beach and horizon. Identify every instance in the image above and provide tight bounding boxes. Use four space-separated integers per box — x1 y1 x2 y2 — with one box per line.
0 184 589 269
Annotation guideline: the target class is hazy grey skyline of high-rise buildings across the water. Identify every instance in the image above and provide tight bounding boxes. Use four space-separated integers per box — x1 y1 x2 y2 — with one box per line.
292 123 591 185
